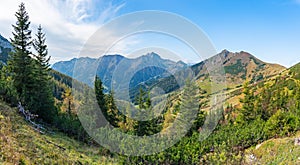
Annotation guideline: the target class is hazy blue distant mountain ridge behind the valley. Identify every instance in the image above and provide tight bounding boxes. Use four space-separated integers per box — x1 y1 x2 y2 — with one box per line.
52 52 187 90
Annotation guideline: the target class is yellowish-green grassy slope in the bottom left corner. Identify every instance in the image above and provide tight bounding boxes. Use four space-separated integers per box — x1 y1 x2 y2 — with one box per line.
0 102 115 164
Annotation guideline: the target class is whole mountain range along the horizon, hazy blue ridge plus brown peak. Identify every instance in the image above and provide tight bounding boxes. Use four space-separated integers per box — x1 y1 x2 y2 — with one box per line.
52 50 286 92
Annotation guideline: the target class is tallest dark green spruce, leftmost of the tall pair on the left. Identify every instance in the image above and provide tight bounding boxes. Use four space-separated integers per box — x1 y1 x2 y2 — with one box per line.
8 3 33 105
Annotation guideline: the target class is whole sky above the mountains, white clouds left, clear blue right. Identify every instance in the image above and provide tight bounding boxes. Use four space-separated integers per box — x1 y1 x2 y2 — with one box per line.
0 0 300 67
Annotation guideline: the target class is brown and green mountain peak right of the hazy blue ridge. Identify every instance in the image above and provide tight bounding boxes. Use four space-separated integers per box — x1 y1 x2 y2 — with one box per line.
192 50 286 86
